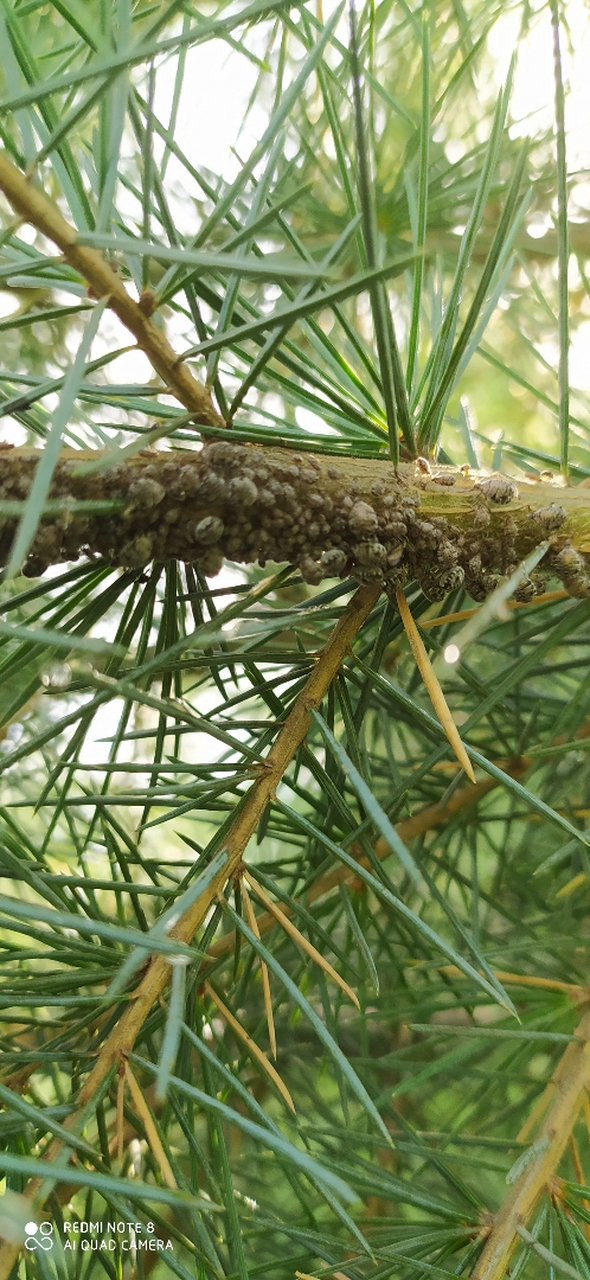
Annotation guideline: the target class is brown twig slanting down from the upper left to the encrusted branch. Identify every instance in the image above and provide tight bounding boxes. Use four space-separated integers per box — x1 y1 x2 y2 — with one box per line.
0 152 224 426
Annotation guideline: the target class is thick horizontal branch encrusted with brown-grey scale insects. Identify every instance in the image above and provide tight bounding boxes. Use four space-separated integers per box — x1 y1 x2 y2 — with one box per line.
0 440 590 600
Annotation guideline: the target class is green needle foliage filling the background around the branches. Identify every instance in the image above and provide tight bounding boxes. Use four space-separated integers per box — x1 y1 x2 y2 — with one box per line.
0 0 590 1280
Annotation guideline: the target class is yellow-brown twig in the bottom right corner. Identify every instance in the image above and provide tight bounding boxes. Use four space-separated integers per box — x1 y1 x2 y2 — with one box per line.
471 1012 590 1280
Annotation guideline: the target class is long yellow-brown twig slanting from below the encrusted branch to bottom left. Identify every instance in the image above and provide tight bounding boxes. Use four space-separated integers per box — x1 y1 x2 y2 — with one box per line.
0 586 380 1280
